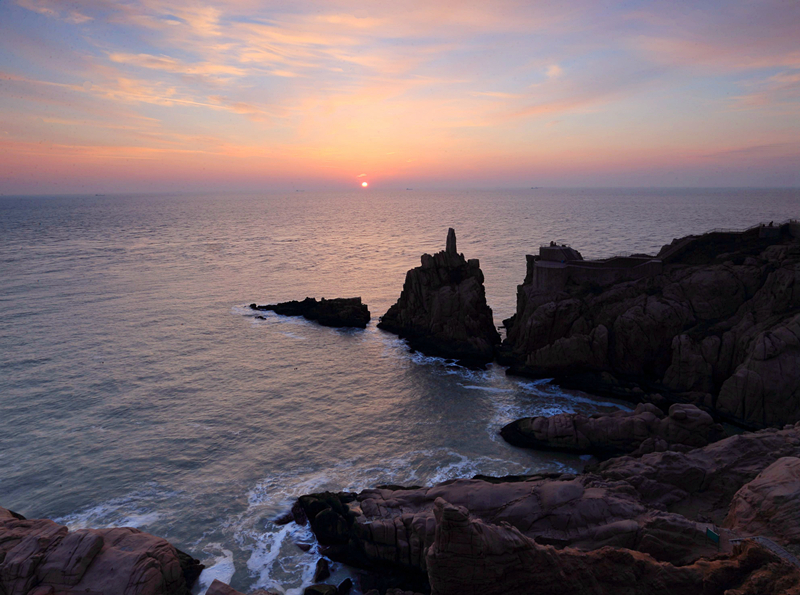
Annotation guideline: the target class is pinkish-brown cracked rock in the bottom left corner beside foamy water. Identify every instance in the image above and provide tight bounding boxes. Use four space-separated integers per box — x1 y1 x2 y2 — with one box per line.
0 509 203 595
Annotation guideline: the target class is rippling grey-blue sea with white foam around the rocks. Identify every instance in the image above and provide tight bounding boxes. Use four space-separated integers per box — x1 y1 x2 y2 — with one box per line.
0 189 800 593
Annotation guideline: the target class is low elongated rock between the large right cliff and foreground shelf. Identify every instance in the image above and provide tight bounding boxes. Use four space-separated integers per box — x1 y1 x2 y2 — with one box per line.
500 403 724 456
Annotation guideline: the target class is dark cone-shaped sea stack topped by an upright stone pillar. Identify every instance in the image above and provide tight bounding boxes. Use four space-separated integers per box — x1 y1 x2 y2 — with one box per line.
378 229 500 364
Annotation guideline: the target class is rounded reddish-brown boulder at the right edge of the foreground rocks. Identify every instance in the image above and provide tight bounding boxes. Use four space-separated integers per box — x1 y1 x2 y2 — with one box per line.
725 457 800 545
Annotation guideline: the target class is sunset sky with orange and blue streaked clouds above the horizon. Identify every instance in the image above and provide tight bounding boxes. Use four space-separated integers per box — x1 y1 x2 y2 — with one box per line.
0 0 800 194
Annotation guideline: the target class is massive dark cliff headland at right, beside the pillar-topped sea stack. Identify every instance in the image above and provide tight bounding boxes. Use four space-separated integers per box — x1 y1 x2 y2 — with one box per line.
502 223 800 427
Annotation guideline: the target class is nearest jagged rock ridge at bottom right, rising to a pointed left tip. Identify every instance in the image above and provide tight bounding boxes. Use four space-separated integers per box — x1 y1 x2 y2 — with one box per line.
427 498 800 595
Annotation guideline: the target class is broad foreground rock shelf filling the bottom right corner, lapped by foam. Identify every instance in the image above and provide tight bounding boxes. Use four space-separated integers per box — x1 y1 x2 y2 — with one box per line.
293 423 800 595
